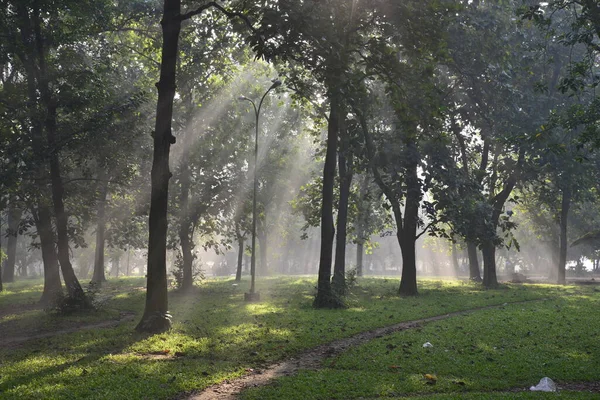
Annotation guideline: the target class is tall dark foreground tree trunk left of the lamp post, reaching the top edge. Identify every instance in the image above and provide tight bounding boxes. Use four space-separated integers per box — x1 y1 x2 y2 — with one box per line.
136 0 181 332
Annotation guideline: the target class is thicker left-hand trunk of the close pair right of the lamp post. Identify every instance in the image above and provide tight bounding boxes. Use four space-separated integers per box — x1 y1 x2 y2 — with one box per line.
313 94 342 308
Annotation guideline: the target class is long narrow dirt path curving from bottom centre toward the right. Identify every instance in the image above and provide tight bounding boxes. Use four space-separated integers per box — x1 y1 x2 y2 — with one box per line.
182 299 546 400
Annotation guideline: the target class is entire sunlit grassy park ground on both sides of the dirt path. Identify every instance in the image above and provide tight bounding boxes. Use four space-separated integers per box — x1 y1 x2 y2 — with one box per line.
0 277 600 399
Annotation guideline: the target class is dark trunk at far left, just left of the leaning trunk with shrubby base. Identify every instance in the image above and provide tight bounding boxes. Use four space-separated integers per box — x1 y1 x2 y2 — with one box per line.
34 206 62 305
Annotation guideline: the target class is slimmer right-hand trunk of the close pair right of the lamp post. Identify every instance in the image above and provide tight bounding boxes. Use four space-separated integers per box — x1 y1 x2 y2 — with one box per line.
331 145 353 295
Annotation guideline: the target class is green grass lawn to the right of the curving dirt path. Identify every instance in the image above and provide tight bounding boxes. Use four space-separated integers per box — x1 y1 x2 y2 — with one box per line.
244 287 600 399
